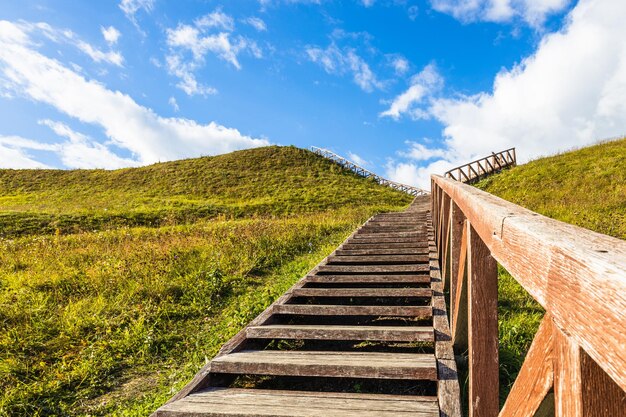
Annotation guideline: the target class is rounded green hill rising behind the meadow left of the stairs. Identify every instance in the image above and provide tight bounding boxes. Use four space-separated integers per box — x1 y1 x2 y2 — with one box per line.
0 146 411 236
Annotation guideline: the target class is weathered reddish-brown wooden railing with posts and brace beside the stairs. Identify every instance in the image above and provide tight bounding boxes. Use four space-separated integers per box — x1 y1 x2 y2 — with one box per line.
431 175 626 416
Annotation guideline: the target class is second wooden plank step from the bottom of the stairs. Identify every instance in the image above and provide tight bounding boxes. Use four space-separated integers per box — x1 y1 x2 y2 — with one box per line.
211 350 437 381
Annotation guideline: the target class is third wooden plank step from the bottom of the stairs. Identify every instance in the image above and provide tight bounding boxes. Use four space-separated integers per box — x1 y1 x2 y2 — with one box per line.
246 324 435 342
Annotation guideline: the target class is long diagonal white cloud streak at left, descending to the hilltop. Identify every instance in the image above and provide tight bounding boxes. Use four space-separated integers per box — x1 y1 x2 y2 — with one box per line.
0 21 269 164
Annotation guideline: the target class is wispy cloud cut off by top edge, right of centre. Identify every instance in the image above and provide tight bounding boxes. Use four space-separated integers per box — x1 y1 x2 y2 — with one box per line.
430 0 570 27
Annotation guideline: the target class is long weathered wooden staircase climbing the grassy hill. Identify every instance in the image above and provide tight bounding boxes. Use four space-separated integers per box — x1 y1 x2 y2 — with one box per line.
154 197 460 417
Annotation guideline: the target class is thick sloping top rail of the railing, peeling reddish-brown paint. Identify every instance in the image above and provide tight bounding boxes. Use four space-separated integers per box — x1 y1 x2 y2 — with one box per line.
432 176 626 390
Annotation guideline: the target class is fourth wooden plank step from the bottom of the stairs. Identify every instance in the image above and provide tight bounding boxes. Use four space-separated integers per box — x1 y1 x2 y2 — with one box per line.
274 304 433 319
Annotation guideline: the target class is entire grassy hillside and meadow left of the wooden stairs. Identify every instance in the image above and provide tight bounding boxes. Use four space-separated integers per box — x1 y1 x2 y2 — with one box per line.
0 147 412 416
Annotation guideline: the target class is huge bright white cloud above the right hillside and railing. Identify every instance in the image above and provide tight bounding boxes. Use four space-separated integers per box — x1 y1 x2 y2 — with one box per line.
390 0 626 188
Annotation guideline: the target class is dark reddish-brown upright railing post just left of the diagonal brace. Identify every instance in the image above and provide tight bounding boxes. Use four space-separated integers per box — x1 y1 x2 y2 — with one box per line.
467 224 499 417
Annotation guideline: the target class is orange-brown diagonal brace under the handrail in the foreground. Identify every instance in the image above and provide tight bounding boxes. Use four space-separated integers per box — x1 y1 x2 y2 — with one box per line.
500 315 554 417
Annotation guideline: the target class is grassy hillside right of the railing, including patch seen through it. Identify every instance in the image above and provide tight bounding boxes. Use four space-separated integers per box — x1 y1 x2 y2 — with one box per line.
477 139 626 399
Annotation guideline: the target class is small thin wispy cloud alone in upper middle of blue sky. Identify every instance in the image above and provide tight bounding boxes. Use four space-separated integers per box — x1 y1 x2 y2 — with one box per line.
306 42 384 93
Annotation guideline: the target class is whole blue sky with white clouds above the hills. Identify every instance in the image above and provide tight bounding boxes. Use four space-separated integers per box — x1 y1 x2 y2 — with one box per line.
0 0 626 186
